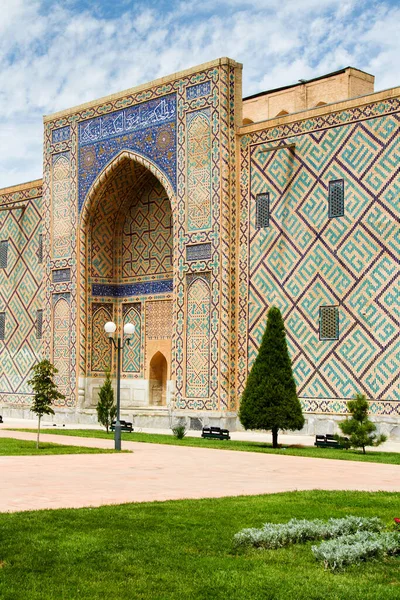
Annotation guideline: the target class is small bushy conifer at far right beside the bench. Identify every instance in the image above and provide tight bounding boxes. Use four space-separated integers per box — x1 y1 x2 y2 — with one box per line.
338 394 387 454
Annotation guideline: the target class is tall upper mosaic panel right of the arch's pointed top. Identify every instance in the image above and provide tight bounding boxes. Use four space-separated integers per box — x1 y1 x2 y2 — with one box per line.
187 109 211 231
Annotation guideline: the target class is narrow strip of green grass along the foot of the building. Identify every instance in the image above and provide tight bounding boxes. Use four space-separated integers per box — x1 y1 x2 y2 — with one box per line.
13 428 400 465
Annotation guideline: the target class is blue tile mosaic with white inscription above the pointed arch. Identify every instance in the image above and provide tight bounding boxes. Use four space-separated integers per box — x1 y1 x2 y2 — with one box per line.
78 94 176 211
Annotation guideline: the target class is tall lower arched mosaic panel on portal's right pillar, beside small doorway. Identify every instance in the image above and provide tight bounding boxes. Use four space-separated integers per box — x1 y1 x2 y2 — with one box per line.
186 275 211 398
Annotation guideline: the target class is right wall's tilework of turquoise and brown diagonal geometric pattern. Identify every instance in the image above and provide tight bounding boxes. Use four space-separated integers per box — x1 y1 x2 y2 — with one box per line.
242 109 400 412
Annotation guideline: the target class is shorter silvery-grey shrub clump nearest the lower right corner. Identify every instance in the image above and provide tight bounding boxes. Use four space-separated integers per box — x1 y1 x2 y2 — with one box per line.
311 531 400 570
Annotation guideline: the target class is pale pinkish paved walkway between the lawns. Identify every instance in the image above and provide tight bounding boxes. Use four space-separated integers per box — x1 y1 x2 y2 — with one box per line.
0 429 400 512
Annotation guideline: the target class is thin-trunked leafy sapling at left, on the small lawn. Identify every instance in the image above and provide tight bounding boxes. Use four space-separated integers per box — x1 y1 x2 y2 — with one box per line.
28 359 65 448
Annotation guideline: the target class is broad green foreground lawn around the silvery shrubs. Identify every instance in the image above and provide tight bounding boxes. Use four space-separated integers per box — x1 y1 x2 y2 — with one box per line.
0 491 400 600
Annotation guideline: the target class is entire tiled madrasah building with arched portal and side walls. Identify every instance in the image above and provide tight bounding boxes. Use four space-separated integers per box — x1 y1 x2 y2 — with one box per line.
0 58 400 437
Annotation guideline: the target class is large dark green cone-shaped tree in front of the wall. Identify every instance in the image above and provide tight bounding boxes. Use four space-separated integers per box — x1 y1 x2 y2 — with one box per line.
239 306 304 448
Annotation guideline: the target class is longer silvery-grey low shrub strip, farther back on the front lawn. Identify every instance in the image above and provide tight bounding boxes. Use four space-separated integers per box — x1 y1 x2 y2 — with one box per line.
234 515 383 549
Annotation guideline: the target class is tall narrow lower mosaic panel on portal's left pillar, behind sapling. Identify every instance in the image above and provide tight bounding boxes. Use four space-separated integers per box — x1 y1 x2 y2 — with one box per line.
52 294 71 406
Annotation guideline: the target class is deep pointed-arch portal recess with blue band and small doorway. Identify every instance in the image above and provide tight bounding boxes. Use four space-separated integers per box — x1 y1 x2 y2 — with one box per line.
81 152 174 409
